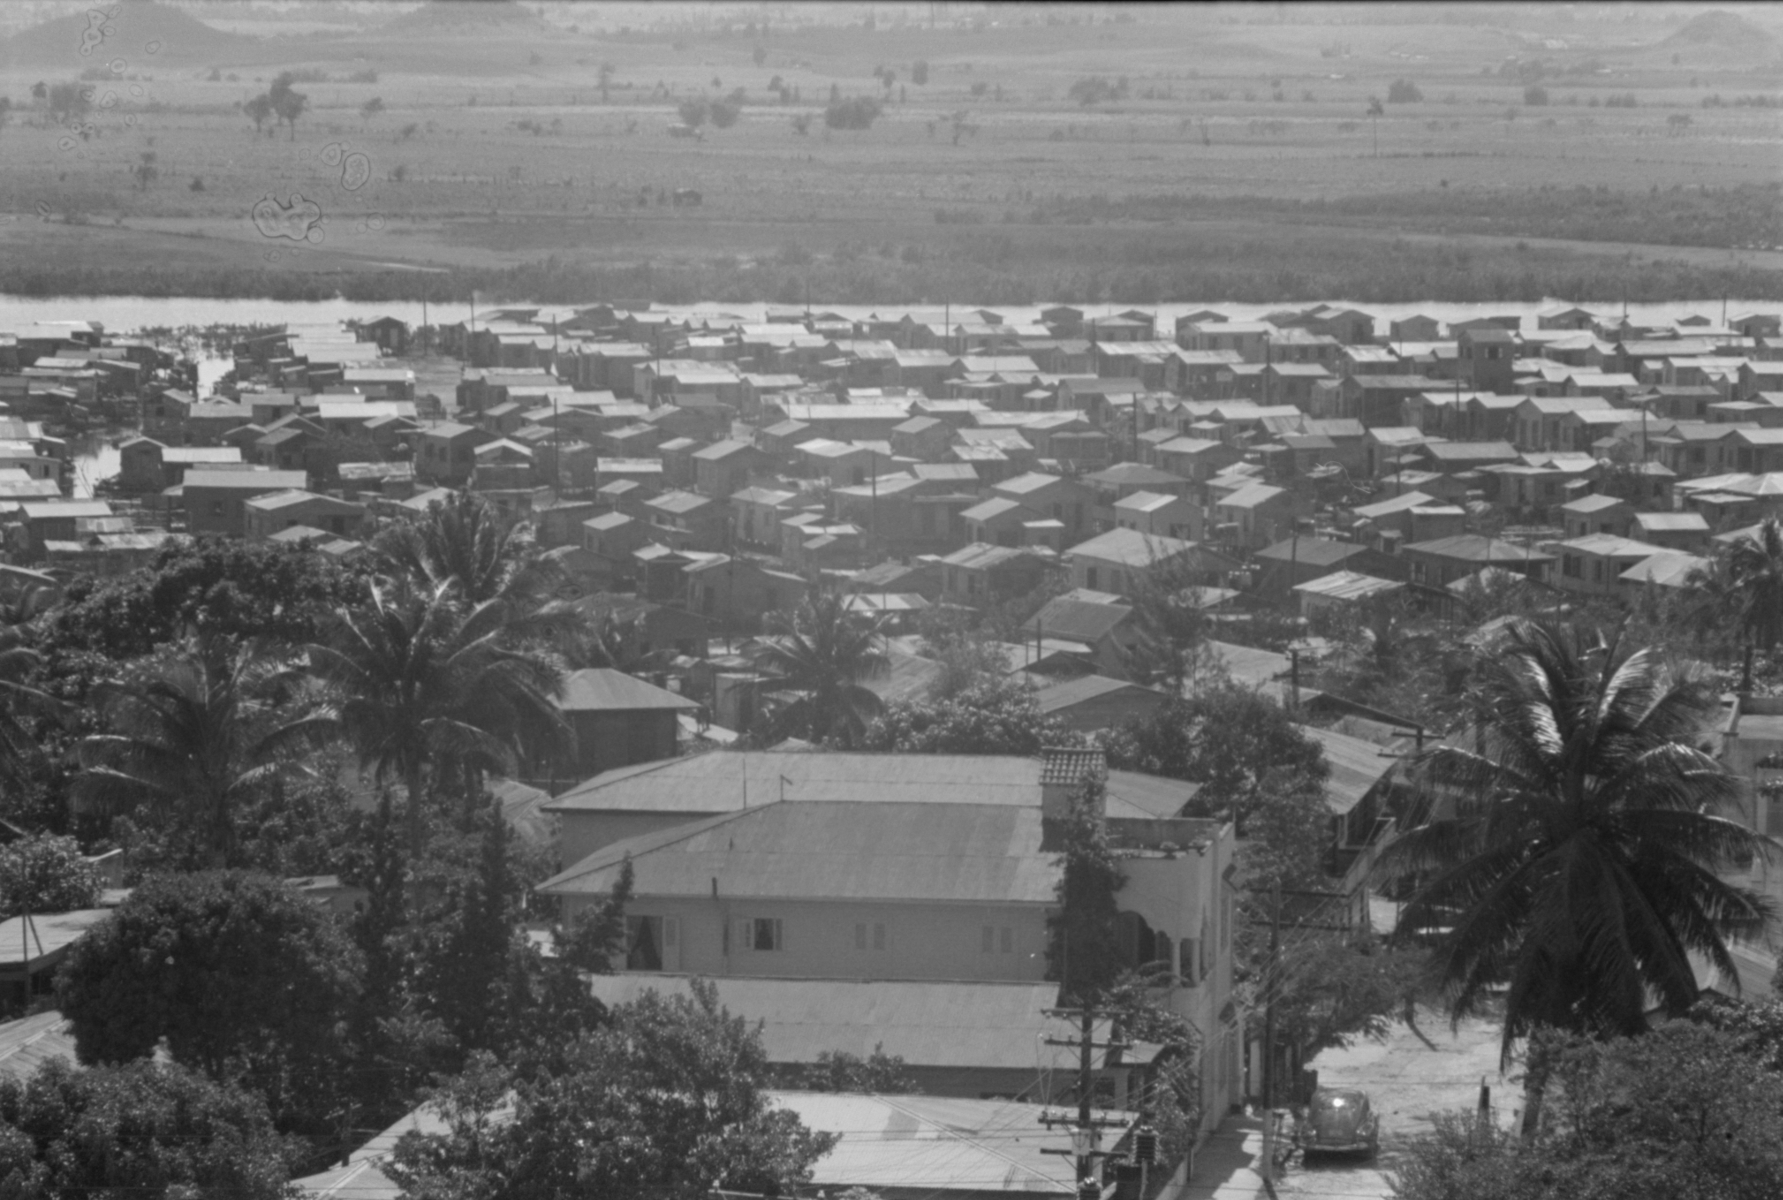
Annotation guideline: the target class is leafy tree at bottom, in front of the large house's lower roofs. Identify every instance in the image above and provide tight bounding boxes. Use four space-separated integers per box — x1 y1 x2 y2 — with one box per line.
389 981 834 1200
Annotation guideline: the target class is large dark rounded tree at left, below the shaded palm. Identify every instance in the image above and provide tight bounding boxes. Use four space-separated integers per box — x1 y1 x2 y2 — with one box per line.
55 872 360 1132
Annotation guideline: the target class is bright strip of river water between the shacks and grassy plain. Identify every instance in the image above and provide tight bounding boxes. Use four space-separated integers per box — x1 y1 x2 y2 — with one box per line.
0 294 1779 496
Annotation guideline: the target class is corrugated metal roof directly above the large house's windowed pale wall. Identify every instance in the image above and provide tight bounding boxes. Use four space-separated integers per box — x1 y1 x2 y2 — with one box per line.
538 798 1057 904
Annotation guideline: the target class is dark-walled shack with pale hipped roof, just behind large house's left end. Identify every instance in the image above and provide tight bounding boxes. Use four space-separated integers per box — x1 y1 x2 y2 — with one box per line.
531 667 699 793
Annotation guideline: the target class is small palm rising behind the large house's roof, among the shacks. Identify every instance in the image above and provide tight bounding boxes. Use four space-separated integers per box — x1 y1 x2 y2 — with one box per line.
751 596 892 744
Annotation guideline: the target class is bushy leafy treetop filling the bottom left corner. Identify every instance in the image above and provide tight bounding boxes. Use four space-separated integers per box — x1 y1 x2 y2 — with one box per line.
0 1061 300 1200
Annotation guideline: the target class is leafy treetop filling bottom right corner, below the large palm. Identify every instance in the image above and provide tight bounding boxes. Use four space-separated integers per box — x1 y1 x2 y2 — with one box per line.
1394 1022 1783 1200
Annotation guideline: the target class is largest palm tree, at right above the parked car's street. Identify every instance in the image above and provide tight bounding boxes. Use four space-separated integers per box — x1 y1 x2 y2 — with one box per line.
1384 621 1772 1104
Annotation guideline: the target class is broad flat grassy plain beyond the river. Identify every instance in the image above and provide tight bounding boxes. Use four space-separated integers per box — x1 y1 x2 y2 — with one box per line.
0 5 1783 301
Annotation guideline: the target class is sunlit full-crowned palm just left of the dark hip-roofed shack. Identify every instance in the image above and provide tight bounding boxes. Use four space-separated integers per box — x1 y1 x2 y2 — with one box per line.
308 581 571 852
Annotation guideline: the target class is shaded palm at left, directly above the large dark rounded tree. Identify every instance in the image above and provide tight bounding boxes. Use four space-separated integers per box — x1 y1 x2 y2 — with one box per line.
73 635 333 867
